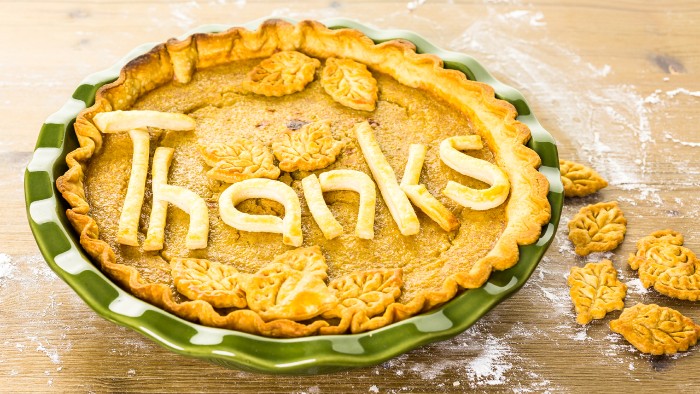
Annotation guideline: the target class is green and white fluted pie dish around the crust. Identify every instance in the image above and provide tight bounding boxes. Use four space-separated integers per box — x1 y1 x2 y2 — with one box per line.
25 19 564 374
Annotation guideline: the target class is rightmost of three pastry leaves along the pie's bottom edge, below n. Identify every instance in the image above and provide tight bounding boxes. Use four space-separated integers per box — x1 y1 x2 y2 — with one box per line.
322 269 403 334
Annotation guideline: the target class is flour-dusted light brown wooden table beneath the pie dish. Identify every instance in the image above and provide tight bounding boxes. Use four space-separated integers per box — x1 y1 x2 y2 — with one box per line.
0 0 700 393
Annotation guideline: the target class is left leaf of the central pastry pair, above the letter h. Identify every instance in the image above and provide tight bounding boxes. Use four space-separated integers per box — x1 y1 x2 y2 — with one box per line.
199 138 280 183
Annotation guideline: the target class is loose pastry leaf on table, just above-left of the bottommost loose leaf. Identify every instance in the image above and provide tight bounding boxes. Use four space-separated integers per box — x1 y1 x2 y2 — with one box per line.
568 260 627 324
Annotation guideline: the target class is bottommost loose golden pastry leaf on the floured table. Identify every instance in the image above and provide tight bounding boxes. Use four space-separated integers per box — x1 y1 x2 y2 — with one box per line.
610 304 700 355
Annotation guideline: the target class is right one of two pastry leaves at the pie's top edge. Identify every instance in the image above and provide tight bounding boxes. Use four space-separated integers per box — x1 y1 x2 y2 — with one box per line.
321 57 377 111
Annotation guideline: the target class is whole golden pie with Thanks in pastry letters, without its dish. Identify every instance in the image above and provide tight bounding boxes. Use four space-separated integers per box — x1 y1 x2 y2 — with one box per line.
56 20 550 337
